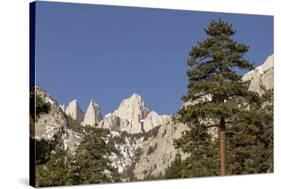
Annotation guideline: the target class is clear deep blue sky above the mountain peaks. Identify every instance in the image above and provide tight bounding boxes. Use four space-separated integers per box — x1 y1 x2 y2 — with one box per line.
35 2 273 114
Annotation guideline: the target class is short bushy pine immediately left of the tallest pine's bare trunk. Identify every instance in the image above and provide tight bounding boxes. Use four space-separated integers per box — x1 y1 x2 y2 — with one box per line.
175 126 219 177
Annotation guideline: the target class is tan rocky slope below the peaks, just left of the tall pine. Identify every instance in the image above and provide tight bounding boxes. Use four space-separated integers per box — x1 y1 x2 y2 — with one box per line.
134 118 188 180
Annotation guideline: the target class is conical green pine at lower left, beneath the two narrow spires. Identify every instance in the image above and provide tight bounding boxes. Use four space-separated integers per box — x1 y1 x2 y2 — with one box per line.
70 128 120 184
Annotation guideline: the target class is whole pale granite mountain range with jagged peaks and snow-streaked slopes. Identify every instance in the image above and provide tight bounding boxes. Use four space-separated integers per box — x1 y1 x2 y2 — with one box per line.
31 55 274 180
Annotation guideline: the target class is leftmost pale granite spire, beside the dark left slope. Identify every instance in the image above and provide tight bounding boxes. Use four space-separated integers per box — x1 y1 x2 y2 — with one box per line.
65 99 84 122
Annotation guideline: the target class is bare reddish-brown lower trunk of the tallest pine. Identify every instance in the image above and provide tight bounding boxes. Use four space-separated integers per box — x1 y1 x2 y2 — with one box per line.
220 118 225 176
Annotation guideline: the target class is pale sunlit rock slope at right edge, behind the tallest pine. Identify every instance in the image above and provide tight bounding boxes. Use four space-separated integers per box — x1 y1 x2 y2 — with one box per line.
242 55 274 95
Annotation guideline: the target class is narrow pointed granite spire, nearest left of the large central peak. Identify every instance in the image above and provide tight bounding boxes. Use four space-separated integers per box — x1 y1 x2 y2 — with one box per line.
82 100 103 126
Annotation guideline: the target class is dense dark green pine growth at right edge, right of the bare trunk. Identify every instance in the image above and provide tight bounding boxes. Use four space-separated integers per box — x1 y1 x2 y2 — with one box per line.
226 91 273 174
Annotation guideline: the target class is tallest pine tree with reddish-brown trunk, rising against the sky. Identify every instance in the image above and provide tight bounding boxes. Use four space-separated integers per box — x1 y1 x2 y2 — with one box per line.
176 20 257 175
